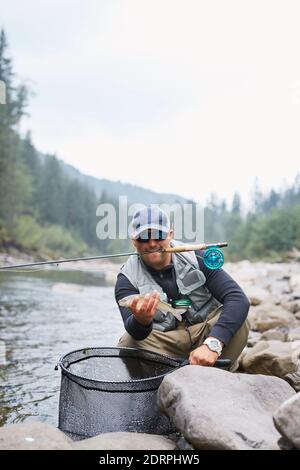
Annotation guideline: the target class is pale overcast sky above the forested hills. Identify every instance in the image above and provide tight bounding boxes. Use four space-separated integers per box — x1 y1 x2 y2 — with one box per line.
0 0 300 207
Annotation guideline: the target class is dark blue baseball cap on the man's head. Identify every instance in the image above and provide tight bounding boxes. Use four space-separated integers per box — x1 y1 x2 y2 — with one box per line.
129 206 170 240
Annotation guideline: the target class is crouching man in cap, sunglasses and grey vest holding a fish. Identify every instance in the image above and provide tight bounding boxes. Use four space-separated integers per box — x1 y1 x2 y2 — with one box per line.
115 206 249 371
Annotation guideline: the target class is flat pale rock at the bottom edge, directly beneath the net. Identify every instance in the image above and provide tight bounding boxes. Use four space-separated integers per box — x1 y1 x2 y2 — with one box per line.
73 432 176 451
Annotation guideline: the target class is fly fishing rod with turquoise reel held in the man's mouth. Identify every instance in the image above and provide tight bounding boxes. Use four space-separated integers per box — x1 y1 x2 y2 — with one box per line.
0 242 228 270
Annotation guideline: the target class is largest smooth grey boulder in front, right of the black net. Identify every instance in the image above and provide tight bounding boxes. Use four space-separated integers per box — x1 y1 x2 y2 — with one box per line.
158 366 295 450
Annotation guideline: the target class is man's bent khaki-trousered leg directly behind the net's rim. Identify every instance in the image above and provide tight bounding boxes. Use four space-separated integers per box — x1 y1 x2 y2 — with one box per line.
118 324 191 359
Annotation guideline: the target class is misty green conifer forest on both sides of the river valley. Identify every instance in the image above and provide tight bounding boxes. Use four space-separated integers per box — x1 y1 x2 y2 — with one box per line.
0 30 300 261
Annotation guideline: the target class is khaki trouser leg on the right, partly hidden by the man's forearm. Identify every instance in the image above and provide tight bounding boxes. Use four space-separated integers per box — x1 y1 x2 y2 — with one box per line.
189 308 250 372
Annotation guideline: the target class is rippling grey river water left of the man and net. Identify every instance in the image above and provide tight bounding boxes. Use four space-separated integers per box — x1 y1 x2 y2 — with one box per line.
0 272 123 426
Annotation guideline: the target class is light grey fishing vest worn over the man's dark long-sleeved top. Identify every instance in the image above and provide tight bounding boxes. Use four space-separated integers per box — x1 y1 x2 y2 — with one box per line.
120 240 222 331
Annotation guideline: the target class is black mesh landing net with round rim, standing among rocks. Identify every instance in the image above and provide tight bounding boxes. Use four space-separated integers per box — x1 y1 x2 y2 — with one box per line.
58 348 183 439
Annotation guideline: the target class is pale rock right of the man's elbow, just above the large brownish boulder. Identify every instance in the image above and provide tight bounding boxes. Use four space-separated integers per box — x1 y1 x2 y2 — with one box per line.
248 304 297 332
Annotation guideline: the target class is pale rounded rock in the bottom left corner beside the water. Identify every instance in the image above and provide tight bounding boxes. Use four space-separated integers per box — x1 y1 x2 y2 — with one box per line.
0 421 72 450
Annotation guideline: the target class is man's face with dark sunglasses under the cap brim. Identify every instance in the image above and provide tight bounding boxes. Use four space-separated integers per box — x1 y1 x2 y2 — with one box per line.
133 230 173 269
